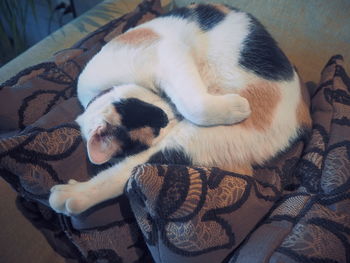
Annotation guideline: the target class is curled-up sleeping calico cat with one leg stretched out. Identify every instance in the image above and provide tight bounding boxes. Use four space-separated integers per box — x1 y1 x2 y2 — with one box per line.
49 4 311 215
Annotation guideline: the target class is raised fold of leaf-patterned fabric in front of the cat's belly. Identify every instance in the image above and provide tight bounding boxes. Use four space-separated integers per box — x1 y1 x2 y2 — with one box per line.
127 123 304 262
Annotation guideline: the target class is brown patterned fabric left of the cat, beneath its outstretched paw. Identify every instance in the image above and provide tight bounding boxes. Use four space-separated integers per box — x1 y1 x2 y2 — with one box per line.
0 0 162 262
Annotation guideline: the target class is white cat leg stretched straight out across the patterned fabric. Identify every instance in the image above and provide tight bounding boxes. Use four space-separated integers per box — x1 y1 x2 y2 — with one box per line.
49 148 156 215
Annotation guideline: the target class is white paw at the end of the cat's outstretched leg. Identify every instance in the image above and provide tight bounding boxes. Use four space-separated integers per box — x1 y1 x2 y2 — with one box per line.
49 180 93 216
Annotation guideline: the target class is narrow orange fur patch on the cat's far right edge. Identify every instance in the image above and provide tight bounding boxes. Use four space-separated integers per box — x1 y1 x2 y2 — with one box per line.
297 79 312 128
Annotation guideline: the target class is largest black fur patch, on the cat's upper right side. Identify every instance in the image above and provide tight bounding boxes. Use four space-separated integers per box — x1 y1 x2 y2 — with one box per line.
239 16 293 80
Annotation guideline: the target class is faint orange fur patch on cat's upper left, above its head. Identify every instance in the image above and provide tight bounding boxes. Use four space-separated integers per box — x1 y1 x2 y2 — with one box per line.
115 28 160 46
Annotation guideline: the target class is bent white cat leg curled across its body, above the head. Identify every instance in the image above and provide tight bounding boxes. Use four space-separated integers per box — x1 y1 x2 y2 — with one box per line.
157 42 251 126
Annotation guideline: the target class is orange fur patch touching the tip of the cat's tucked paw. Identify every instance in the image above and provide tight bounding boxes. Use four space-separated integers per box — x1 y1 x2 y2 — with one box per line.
240 82 281 131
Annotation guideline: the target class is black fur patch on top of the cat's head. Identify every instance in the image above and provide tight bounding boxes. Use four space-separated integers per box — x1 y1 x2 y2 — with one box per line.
113 98 169 134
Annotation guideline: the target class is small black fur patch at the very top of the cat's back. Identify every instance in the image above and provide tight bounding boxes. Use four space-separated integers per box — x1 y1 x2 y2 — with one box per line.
195 5 225 31
